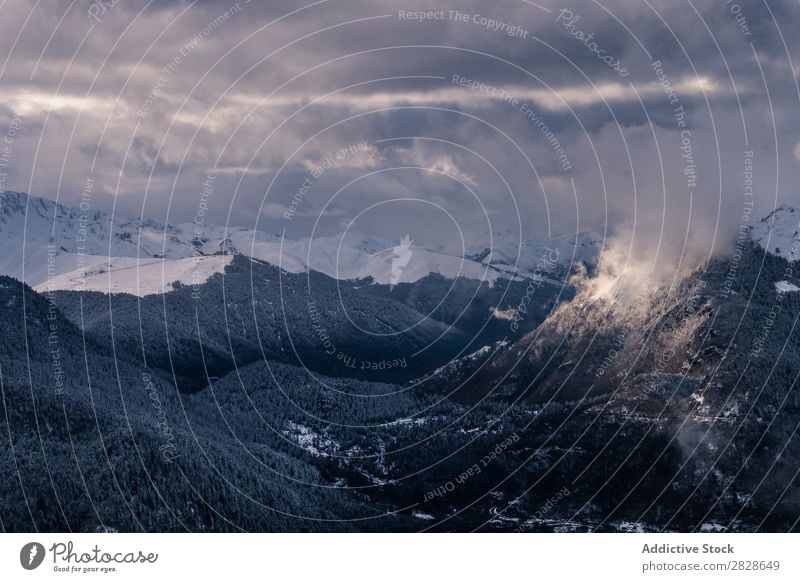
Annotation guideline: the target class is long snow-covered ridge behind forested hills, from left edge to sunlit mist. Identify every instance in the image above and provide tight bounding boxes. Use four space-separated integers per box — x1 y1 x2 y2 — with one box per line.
0 192 602 296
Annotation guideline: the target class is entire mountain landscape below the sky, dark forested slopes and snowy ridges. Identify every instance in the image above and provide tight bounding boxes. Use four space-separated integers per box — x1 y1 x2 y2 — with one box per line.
0 194 800 532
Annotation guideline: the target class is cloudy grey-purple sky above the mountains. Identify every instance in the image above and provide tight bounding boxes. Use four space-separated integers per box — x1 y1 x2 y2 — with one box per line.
0 0 800 260
